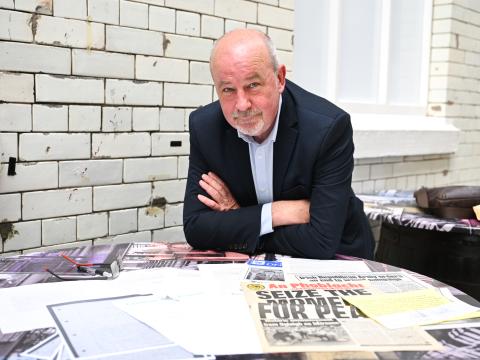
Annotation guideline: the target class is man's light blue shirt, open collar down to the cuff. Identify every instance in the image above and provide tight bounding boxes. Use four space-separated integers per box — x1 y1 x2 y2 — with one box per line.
237 96 282 236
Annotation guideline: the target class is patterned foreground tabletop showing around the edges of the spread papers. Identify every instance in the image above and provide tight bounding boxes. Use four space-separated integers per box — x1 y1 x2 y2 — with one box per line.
0 244 480 360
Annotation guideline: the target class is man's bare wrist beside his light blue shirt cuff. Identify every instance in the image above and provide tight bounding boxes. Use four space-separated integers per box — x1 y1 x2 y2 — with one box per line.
272 200 310 227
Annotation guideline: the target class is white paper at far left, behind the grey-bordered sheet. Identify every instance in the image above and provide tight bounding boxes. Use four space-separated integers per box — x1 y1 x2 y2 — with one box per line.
0 268 202 333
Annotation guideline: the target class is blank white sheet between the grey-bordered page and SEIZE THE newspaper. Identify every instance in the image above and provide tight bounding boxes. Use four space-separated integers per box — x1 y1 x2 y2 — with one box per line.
115 289 262 355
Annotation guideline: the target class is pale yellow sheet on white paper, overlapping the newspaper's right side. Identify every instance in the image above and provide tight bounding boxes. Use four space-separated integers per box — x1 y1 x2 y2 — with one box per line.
342 289 479 329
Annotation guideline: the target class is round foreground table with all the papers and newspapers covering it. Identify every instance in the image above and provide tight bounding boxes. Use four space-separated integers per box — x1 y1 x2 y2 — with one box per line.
0 243 480 359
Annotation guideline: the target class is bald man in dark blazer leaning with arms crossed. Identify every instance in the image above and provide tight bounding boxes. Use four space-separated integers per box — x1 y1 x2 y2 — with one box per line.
183 29 373 259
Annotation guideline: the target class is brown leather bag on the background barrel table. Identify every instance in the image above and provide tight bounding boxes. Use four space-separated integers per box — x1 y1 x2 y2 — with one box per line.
414 186 480 219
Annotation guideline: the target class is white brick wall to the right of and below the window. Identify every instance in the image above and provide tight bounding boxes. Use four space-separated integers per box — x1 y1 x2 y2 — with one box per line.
353 0 480 193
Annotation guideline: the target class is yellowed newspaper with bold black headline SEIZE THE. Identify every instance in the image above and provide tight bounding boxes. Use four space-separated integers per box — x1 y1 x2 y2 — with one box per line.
242 282 441 352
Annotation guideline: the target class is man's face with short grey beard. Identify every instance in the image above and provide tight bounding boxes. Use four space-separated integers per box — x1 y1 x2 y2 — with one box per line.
212 37 285 143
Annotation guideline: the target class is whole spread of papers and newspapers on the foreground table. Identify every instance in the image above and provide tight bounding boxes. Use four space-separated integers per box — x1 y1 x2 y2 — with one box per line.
0 258 480 359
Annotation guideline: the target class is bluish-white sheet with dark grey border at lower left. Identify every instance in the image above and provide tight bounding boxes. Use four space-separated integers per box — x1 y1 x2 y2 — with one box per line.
48 297 199 359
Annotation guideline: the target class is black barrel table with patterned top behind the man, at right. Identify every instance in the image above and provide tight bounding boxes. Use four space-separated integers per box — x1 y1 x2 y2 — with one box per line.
360 192 480 300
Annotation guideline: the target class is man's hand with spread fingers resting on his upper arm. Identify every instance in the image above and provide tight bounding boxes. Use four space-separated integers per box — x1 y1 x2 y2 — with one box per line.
197 171 240 211
